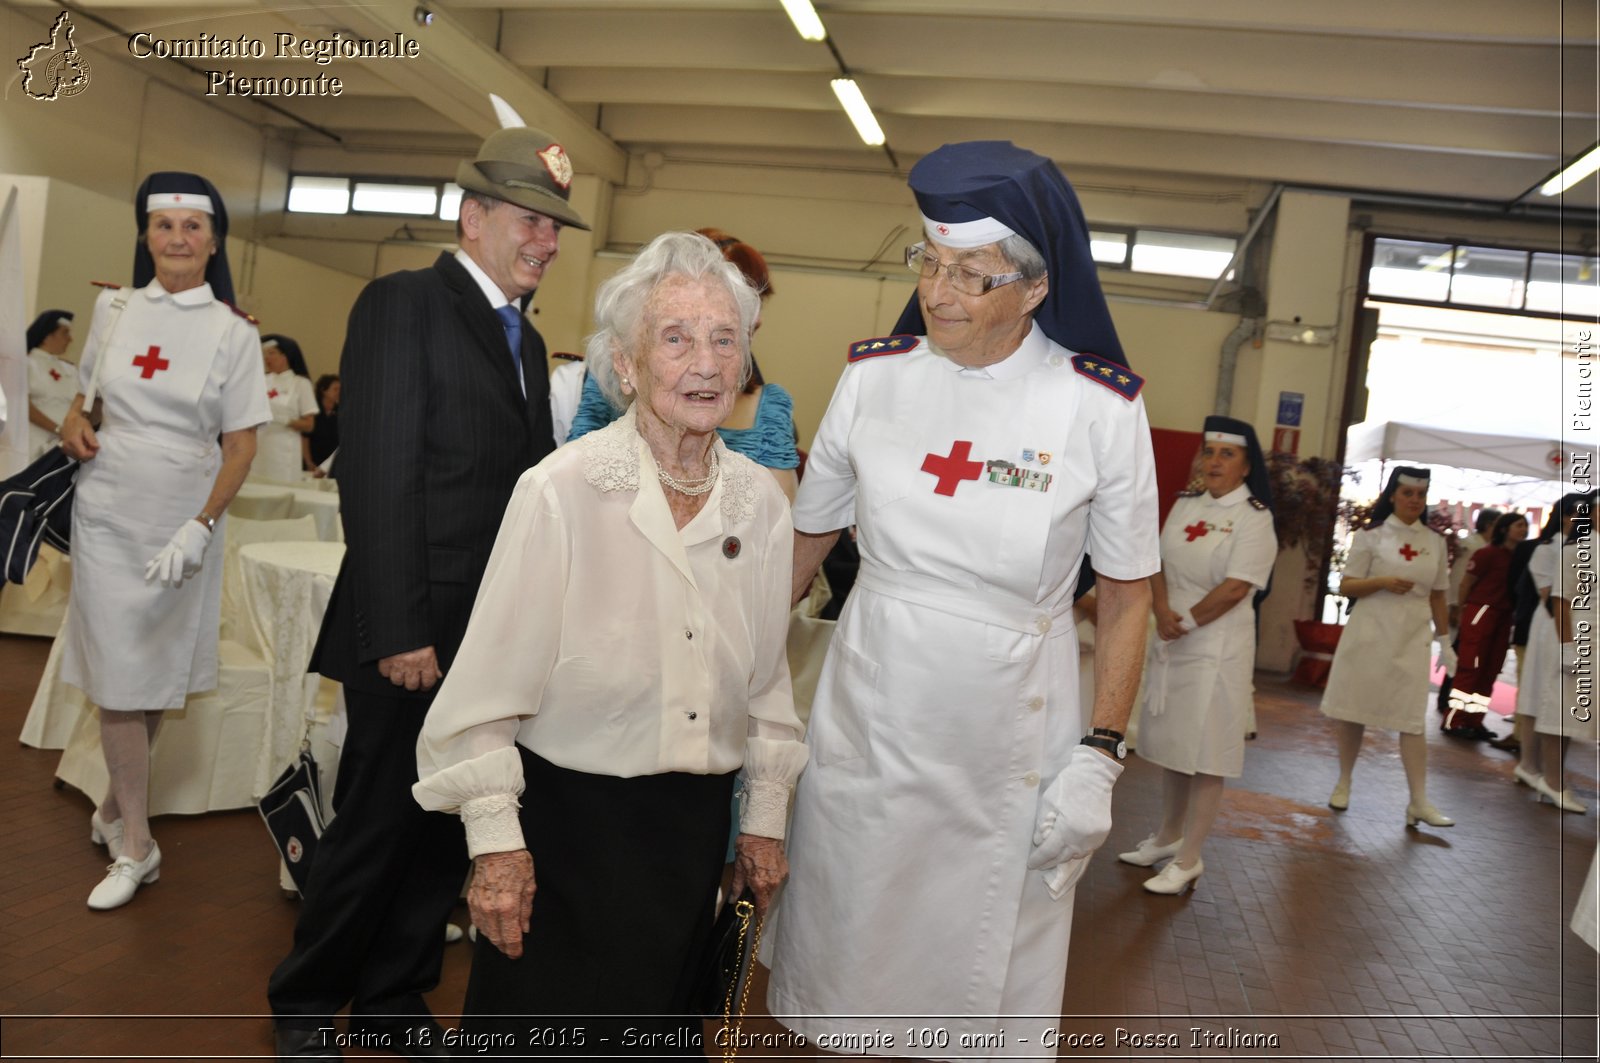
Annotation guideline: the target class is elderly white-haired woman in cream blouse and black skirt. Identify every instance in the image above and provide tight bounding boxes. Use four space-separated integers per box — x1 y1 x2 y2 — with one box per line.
414 232 806 1055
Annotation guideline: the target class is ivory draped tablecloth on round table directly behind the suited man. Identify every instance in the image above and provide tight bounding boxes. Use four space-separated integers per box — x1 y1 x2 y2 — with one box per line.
238 543 344 796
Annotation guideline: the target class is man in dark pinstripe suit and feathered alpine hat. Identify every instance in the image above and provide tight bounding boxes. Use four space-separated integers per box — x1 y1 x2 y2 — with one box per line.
267 128 589 1058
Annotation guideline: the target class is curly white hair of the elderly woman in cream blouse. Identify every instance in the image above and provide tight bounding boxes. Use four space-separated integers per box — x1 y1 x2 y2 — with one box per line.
584 232 762 410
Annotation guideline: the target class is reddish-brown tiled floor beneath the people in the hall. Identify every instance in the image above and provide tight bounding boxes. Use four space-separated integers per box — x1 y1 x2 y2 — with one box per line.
0 627 1597 1060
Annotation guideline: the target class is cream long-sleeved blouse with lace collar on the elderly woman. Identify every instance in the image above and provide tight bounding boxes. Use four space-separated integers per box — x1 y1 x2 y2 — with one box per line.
413 408 806 856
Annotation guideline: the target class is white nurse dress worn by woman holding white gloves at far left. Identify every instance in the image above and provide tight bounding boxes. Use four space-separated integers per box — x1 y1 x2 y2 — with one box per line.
61 280 269 711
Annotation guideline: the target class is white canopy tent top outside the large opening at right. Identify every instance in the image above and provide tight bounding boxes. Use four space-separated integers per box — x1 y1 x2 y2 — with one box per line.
1344 421 1574 482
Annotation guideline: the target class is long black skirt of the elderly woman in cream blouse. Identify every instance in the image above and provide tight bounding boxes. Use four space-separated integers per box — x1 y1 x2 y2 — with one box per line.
458 746 736 1058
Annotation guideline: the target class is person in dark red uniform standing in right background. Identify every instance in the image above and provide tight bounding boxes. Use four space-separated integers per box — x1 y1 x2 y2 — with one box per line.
1442 512 1528 738
